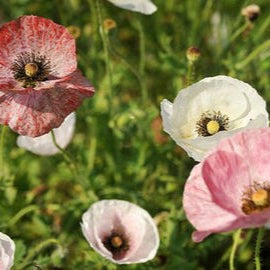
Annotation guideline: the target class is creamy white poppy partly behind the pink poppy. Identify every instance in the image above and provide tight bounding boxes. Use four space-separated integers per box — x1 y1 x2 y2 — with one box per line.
161 75 268 161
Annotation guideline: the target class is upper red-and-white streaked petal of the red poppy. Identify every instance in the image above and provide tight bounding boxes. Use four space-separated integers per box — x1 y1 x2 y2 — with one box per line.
0 16 77 78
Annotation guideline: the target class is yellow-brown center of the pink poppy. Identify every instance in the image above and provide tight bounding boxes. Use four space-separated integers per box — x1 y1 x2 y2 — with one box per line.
241 182 270 215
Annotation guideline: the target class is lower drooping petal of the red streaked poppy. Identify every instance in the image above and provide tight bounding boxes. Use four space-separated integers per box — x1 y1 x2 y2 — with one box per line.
0 70 94 137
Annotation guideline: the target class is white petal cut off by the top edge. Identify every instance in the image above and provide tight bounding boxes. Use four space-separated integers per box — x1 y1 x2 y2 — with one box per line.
108 0 157 15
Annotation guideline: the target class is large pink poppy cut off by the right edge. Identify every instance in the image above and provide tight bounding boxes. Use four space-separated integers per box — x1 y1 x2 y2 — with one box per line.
183 128 270 242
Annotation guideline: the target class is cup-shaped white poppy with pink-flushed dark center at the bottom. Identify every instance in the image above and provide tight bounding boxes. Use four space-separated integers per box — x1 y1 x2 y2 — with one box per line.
81 200 159 264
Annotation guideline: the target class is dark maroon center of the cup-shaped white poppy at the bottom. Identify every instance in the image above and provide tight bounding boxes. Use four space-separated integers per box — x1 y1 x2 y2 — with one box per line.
102 230 129 260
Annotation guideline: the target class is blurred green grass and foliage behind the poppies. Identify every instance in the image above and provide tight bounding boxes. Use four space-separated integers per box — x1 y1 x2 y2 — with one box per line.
0 0 270 270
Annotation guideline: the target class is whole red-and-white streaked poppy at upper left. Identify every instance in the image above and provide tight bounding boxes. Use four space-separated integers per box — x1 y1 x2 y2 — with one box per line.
0 16 94 137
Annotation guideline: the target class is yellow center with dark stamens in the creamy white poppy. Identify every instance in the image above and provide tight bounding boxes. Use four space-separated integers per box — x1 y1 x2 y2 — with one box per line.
196 111 229 137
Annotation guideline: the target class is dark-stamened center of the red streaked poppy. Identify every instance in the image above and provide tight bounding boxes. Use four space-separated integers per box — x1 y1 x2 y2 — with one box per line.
11 52 50 88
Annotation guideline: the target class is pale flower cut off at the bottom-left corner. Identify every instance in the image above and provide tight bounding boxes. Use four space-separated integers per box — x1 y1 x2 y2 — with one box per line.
0 232 15 270
